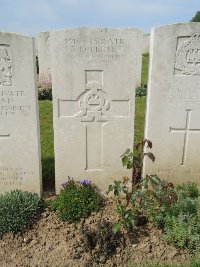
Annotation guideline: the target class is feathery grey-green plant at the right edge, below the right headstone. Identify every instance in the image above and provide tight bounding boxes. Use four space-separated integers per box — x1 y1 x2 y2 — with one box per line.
163 183 200 250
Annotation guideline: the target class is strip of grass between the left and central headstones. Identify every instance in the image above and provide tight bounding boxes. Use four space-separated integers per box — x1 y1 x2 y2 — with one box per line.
39 100 55 191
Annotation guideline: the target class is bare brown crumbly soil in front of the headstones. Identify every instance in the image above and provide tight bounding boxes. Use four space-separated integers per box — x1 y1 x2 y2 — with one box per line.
0 199 189 267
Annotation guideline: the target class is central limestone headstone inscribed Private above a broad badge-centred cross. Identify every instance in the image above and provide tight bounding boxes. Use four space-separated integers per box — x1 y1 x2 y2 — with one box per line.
50 28 142 192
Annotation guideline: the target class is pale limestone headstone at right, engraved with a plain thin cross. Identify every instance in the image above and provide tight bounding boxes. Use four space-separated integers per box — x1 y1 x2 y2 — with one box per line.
144 23 200 183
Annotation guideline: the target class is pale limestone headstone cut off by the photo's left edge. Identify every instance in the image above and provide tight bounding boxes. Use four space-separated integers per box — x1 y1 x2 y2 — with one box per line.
0 32 41 195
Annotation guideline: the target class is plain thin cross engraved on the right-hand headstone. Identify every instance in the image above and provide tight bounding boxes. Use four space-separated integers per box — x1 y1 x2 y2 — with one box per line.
170 109 200 166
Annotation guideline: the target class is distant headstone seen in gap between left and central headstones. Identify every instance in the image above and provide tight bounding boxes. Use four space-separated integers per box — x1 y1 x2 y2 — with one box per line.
37 32 51 84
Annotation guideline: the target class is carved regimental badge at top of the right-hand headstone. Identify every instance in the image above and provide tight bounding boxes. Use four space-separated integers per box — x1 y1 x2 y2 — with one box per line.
175 32 200 75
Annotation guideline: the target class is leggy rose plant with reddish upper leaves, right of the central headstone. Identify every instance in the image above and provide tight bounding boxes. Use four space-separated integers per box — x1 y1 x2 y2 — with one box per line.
107 139 157 232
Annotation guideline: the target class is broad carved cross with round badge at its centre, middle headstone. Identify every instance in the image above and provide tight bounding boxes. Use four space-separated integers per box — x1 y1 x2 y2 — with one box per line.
58 70 130 170
